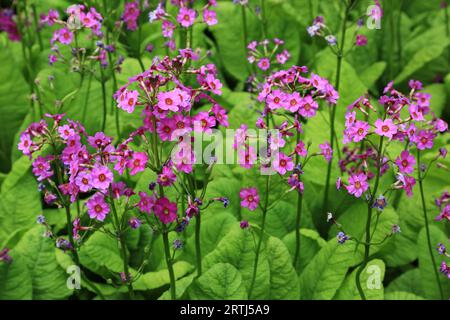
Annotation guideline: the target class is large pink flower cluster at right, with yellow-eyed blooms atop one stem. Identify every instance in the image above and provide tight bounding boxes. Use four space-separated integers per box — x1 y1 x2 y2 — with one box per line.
337 80 448 197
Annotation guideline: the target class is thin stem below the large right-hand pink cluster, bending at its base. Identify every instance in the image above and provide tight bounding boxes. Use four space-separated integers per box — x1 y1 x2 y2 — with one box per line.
356 136 384 300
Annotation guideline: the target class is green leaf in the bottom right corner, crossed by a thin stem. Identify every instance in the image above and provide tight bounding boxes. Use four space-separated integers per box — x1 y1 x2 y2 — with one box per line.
417 225 450 300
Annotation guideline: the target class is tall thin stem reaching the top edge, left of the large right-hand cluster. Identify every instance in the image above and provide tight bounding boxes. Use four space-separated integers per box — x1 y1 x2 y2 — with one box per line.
322 1 353 218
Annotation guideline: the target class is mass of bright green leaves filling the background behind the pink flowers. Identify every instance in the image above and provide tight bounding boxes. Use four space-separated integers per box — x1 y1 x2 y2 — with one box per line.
0 0 450 299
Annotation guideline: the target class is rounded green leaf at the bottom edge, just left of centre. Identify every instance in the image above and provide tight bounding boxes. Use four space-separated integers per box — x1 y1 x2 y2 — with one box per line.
187 263 247 300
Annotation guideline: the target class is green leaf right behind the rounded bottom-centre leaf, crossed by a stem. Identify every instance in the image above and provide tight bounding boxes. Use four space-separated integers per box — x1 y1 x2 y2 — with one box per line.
203 226 270 299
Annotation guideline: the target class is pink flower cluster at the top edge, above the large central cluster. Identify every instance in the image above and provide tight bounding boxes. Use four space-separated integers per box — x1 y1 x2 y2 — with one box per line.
149 0 218 51
